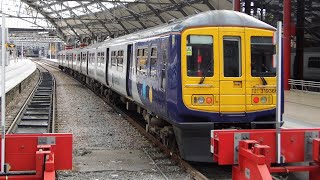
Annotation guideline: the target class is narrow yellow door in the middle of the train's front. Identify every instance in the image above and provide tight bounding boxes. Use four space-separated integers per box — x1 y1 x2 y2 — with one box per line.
219 28 246 115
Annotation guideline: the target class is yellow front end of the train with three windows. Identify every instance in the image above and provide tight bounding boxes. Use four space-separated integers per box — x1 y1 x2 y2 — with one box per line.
181 27 276 114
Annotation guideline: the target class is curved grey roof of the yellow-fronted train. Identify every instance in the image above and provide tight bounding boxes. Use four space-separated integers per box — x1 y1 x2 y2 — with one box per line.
100 10 276 44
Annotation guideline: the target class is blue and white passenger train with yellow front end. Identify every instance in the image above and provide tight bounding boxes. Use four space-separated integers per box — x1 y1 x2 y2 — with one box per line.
59 10 276 162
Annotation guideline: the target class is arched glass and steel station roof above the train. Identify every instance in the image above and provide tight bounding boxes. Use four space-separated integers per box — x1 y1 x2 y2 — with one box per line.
4 0 232 41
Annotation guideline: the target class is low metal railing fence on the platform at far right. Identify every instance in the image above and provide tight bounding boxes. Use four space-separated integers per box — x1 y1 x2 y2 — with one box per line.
289 79 320 92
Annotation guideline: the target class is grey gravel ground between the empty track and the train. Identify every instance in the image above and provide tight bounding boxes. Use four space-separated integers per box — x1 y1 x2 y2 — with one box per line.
44 65 191 180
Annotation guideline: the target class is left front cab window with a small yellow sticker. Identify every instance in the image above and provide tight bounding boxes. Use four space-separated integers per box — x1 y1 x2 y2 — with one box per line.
186 35 213 77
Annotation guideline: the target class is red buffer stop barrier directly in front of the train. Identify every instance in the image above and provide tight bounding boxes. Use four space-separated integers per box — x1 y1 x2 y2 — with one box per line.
211 129 320 180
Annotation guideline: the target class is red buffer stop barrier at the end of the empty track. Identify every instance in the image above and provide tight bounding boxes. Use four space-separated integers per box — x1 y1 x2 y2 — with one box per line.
0 134 72 180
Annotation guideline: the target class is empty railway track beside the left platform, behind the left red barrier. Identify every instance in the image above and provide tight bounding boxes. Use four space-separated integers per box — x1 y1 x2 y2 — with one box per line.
7 63 55 134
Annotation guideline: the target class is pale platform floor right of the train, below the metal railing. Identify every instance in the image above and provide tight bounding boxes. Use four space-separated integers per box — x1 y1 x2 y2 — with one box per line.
283 90 320 128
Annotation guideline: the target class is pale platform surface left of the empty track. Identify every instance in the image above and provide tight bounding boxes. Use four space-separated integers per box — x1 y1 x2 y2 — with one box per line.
0 59 37 97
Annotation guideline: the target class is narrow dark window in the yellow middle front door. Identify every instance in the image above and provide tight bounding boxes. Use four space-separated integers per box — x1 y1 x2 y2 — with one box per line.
223 37 242 77
